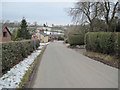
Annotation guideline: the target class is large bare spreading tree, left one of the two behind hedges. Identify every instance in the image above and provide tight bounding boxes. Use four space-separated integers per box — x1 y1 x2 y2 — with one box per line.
69 2 104 31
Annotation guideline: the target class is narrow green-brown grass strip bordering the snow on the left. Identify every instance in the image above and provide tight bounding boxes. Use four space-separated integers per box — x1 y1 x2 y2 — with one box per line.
19 46 46 88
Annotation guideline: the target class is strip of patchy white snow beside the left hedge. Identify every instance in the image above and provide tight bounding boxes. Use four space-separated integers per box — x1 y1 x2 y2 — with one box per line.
0 43 49 90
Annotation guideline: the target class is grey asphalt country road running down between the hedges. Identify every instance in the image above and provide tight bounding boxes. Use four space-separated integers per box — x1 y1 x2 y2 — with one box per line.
31 41 118 88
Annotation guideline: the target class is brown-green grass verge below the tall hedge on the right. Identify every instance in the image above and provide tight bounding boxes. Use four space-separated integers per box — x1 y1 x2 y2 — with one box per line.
83 52 120 69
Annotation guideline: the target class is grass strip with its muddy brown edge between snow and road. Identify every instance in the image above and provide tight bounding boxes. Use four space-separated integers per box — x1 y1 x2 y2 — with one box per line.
19 46 47 88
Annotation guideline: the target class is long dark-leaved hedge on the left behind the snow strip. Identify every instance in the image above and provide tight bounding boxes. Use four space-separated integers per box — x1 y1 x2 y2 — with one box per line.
2 40 40 73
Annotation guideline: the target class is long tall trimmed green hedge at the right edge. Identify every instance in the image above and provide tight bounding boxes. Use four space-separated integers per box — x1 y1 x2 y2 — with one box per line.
85 32 120 56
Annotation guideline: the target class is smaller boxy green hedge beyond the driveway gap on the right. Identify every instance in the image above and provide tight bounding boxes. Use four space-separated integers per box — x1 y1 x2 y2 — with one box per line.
68 34 84 46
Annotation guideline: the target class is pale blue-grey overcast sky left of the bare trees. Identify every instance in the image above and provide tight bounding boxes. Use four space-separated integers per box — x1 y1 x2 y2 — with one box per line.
2 1 75 25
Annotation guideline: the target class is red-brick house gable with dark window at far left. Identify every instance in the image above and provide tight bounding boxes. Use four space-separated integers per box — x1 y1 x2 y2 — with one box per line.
0 26 12 42
